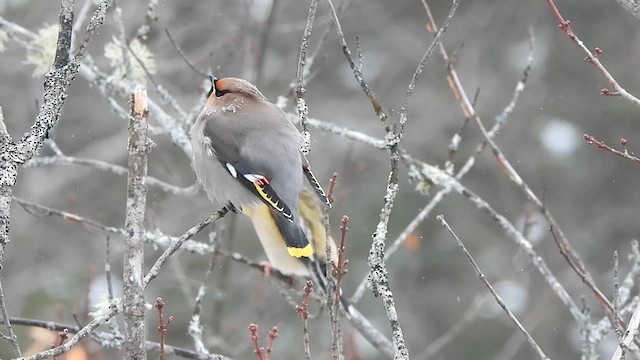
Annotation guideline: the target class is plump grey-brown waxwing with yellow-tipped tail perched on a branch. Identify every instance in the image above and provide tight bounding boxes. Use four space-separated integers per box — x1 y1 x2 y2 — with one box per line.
190 76 335 286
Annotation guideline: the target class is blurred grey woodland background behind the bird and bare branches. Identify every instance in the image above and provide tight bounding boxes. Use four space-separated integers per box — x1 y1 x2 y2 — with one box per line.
0 0 640 359
